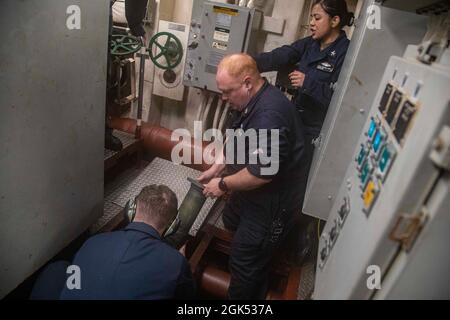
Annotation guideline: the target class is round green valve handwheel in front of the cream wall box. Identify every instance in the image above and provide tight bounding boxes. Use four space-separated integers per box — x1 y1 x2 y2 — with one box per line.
149 32 183 70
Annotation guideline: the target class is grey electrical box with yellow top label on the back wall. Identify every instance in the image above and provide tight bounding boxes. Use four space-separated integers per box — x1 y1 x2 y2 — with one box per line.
184 0 262 92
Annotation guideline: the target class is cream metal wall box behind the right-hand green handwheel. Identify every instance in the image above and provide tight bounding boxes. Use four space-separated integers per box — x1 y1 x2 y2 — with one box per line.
153 20 189 101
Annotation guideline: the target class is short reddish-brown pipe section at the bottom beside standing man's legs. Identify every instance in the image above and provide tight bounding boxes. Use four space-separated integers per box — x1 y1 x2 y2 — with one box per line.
200 265 231 299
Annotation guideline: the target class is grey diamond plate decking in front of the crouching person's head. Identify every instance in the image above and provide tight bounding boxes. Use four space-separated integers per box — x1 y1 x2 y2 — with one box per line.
105 158 215 236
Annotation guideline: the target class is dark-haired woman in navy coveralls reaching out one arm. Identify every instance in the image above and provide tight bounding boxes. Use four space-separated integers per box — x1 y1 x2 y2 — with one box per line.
255 0 354 168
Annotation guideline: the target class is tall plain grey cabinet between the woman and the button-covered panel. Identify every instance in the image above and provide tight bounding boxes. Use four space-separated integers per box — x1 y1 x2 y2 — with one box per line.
303 1 427 220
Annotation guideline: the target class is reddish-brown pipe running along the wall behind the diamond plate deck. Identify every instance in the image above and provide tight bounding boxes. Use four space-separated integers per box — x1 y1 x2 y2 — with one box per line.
109 118 211 171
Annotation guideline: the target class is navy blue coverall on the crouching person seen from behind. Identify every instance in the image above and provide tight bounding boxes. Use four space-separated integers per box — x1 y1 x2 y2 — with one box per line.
60 222 194 300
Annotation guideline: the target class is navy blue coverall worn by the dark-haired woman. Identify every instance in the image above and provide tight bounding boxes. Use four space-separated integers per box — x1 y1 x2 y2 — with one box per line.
254 31 350 176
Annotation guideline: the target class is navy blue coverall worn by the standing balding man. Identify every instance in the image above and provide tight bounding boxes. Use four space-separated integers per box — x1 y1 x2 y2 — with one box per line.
223 82 306 299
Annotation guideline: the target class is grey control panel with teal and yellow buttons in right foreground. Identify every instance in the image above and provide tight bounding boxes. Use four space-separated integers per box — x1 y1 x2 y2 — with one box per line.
314 57 450 299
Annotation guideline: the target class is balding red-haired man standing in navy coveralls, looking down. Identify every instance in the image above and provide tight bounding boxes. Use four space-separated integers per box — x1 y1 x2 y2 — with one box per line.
199 54 306 299
